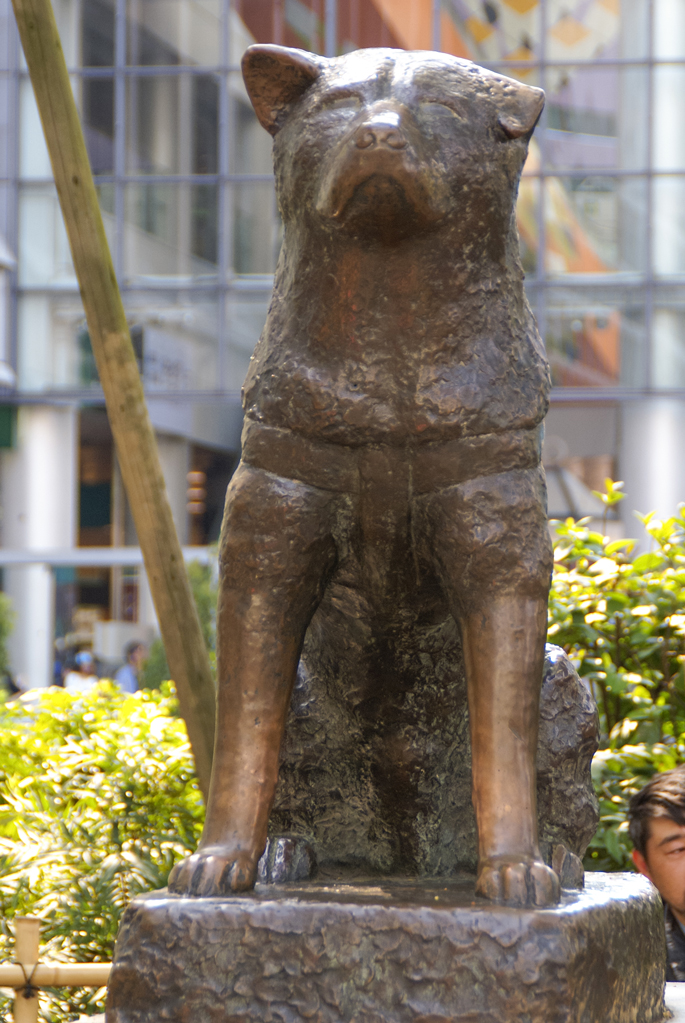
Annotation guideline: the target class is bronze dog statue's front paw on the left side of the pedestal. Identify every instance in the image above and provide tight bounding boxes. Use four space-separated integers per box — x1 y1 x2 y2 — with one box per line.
169 845 257 898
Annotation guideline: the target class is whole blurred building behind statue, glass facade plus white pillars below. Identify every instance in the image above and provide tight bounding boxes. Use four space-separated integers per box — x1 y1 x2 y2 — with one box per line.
0 0 685 685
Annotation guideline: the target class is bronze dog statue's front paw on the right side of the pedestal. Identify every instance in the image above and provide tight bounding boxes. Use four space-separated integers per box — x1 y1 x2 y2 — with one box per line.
475 856 560 906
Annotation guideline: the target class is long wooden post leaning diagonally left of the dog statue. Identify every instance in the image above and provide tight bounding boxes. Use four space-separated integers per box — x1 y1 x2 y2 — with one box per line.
12 0 215 794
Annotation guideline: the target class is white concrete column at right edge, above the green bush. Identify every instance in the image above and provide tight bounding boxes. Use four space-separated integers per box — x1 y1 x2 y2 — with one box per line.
619 397 685 549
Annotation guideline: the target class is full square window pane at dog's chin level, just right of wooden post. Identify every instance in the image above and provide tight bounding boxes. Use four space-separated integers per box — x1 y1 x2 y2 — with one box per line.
124 184 217 278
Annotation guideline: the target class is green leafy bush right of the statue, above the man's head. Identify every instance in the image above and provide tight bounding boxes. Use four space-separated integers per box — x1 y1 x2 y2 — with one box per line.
548 493 685 871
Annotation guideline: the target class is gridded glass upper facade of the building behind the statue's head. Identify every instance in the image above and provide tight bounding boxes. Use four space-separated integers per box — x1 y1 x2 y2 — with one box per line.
0 0 685 400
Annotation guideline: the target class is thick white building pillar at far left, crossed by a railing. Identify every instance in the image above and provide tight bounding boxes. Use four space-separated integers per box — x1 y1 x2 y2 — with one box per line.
2 405 78 688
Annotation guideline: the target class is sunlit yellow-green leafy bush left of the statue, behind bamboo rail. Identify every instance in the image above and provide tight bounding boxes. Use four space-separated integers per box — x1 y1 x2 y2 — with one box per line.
0 681 203 1021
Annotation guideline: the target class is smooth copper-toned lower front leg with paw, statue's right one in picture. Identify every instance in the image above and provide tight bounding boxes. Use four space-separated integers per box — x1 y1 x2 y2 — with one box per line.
462 594 559 906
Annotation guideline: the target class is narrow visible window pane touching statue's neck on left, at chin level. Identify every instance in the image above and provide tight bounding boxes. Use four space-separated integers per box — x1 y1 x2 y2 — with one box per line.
231 182 281 273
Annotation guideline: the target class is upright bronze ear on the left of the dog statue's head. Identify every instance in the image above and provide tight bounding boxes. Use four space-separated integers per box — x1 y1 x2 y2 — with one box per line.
241 44 324 135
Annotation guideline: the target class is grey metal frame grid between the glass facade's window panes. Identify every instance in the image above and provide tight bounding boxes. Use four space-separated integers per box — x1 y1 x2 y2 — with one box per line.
0 0 685 401
